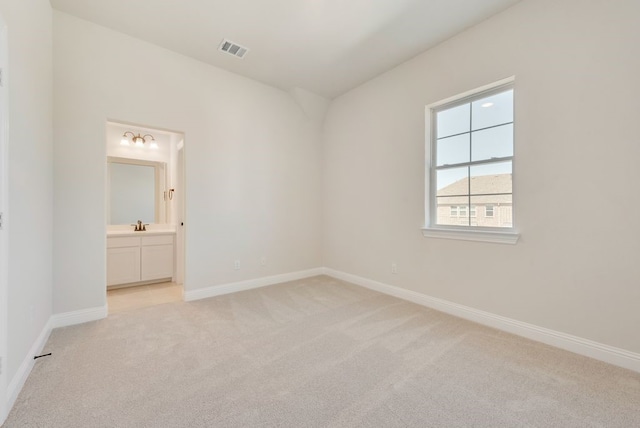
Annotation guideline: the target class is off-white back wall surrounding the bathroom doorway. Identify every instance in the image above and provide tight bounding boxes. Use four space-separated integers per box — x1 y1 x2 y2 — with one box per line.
53 12 321 313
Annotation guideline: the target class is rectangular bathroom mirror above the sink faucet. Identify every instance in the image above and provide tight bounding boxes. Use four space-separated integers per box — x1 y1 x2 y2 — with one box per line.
107 156 166 225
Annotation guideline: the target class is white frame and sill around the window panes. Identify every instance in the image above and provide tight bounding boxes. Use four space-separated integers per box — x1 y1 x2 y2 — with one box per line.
422 77 520 244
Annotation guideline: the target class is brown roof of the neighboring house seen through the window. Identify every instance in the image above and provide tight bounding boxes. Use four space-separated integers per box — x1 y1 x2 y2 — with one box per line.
437 174 513 205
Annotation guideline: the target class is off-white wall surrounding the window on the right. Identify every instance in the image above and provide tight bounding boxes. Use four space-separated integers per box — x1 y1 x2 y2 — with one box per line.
323 0 640 352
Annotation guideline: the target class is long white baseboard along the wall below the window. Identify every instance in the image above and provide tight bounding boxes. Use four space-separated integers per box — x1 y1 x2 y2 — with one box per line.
324 268 640 372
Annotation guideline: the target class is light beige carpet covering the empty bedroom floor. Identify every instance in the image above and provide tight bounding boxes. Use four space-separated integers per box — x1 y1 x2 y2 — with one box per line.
5 276 640 427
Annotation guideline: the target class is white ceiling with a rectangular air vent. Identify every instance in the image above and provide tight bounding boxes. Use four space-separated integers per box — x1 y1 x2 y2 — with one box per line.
51 0 519 98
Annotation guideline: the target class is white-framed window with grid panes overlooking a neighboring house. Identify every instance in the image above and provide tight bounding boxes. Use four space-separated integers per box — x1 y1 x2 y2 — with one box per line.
425 79 517 243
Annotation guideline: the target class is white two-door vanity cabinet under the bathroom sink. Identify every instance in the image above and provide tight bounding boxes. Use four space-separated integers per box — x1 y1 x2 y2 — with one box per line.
107 232 174 286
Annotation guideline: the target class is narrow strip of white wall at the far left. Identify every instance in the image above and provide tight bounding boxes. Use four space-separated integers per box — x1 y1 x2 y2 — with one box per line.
0 0 53 404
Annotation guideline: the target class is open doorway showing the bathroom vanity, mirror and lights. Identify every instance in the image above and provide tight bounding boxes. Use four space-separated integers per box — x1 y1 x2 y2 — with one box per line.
106 121 185 315
